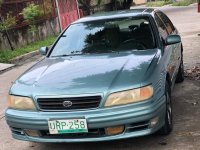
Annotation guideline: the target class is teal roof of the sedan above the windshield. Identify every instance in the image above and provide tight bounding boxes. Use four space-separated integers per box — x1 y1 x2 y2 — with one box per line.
74 8 155 23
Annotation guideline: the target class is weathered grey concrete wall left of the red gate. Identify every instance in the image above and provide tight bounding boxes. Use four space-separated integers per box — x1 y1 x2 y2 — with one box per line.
0 18 60 50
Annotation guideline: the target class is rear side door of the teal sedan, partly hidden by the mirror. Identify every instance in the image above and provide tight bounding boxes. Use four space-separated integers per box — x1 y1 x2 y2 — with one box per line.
156 11 181 84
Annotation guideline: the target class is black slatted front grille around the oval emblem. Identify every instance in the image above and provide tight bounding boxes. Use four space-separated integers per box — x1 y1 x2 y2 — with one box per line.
37 96 101 111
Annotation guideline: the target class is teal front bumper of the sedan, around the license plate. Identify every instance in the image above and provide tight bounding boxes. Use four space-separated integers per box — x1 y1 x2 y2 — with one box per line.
6 96 166 142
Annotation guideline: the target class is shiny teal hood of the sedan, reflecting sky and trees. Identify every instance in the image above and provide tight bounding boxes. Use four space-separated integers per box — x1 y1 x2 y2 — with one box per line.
11 49 157 96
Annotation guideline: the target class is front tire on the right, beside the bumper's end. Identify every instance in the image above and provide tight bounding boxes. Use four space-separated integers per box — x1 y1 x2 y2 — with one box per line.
158 81 173 135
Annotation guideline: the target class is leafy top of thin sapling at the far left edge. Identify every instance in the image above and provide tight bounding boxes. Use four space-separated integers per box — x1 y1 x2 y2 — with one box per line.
0 13 16 32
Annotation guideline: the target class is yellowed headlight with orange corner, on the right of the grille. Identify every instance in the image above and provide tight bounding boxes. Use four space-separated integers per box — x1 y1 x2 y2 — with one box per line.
105 85 153 107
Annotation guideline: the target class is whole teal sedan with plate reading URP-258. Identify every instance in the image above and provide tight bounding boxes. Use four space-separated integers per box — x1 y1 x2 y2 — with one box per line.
6 8 184 142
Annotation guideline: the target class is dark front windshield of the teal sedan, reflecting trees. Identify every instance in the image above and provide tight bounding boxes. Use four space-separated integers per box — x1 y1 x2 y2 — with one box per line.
51 17 155 57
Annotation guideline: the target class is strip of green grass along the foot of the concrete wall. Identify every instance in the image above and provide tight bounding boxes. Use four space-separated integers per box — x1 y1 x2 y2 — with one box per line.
0 36 57 63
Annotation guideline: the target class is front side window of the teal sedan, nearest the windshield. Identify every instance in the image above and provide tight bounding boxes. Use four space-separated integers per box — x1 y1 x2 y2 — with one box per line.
155 14 168 40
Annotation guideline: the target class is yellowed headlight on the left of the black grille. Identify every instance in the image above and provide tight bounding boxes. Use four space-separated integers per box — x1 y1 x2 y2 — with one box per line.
8 95 36 110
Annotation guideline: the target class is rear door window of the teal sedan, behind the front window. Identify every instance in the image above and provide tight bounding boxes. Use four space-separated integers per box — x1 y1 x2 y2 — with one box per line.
157 12 175 34
